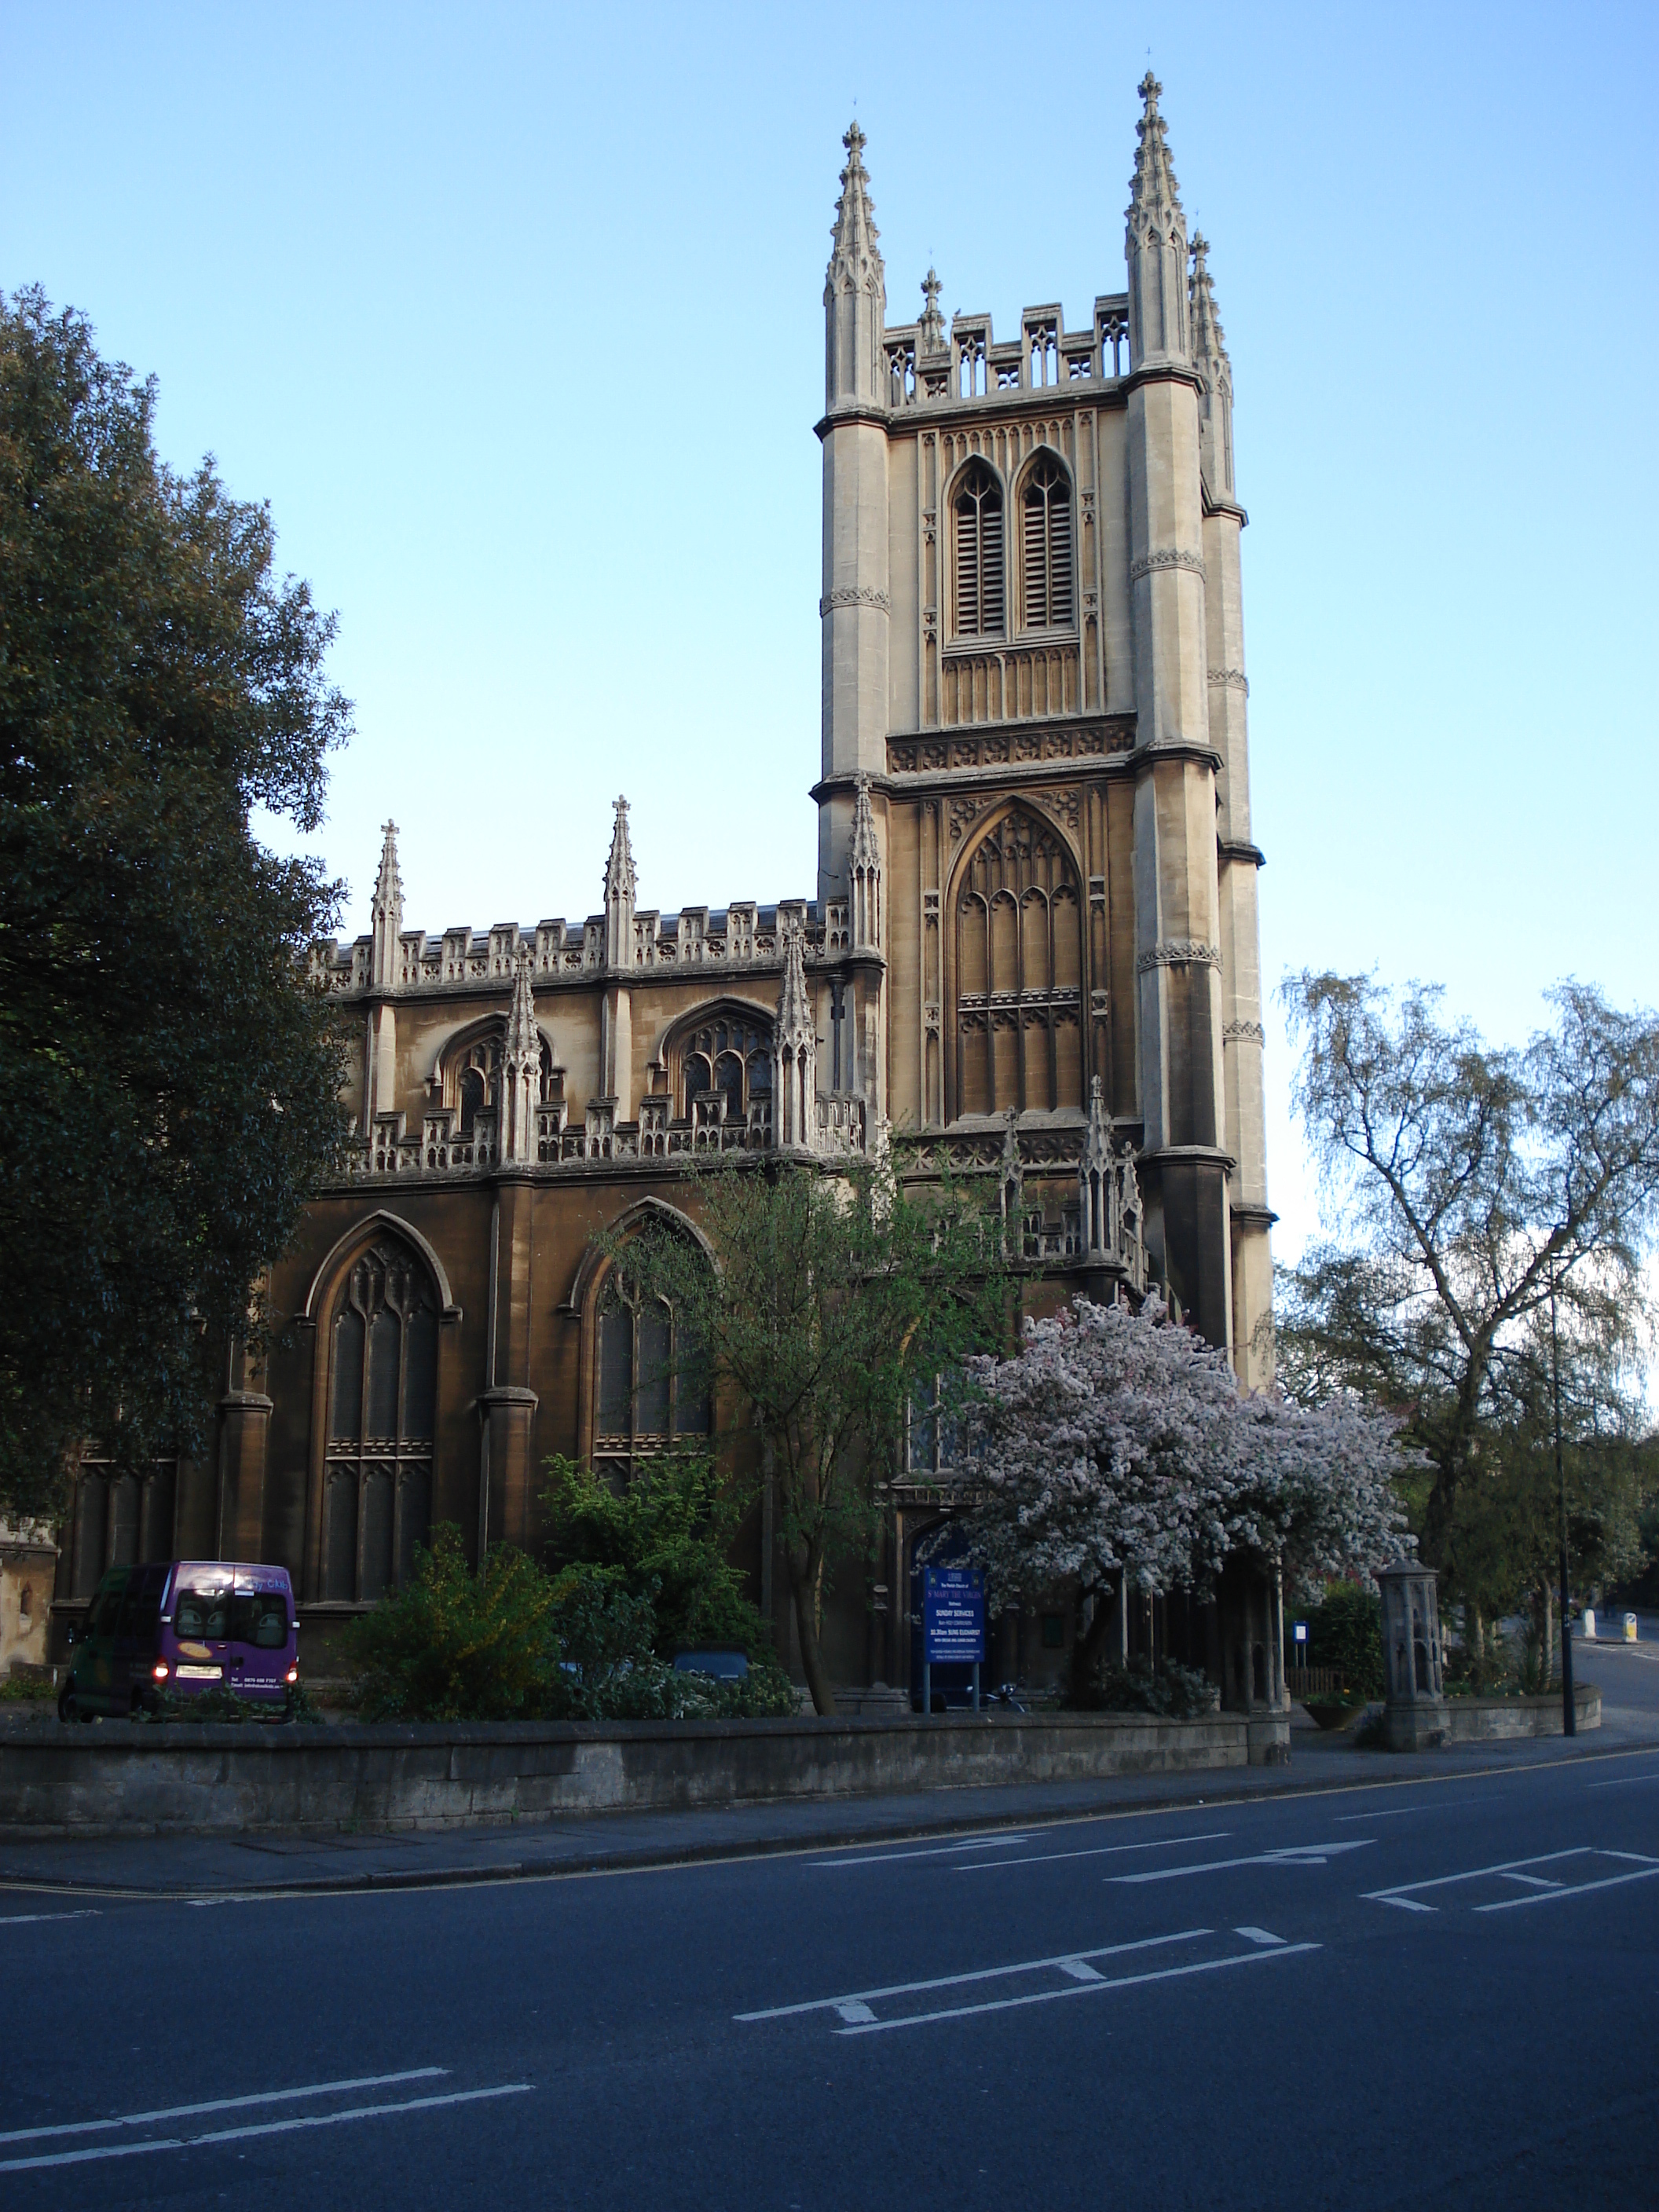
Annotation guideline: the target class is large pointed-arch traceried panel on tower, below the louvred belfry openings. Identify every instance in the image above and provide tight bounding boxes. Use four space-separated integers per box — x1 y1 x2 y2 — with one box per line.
951 808 1084 1115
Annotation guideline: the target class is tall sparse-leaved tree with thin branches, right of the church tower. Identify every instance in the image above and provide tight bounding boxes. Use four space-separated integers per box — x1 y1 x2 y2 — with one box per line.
1276 973 1659 1593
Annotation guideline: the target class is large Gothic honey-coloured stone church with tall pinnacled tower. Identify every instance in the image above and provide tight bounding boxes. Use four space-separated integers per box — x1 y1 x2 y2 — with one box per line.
55 75 1274 1688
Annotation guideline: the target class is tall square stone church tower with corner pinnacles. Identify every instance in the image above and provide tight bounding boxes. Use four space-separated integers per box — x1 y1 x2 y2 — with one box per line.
814 75 1274 1380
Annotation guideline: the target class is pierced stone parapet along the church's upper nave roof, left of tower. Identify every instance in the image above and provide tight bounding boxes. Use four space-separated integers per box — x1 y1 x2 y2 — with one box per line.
309 898 851 993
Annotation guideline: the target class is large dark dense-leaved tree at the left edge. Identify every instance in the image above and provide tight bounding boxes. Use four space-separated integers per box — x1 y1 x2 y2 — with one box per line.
0 290 350 1513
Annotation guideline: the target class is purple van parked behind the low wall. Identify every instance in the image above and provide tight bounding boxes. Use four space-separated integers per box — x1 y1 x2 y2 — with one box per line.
57 1559 298 1721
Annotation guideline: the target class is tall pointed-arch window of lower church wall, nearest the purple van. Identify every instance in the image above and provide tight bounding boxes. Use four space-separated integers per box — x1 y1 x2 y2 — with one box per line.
323 1241 438 1602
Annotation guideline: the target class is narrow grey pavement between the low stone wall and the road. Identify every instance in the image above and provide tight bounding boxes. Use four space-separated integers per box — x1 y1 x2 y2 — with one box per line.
0 1643 1659 1895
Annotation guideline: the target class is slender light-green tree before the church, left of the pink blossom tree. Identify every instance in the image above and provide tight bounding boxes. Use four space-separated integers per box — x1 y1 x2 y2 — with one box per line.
604 1161 1006 1714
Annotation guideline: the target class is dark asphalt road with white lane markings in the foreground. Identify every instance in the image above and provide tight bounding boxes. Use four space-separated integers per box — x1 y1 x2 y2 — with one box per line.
0 1725 1659 2212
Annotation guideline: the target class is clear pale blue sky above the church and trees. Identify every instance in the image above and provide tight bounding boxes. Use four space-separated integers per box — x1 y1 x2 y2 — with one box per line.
0 0 1659 1252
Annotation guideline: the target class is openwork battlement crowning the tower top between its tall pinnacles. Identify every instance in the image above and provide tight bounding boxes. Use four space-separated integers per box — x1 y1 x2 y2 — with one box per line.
883 292 1128 409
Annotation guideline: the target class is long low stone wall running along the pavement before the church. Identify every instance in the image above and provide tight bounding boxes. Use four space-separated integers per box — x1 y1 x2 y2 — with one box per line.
0 1712 1256 1838
